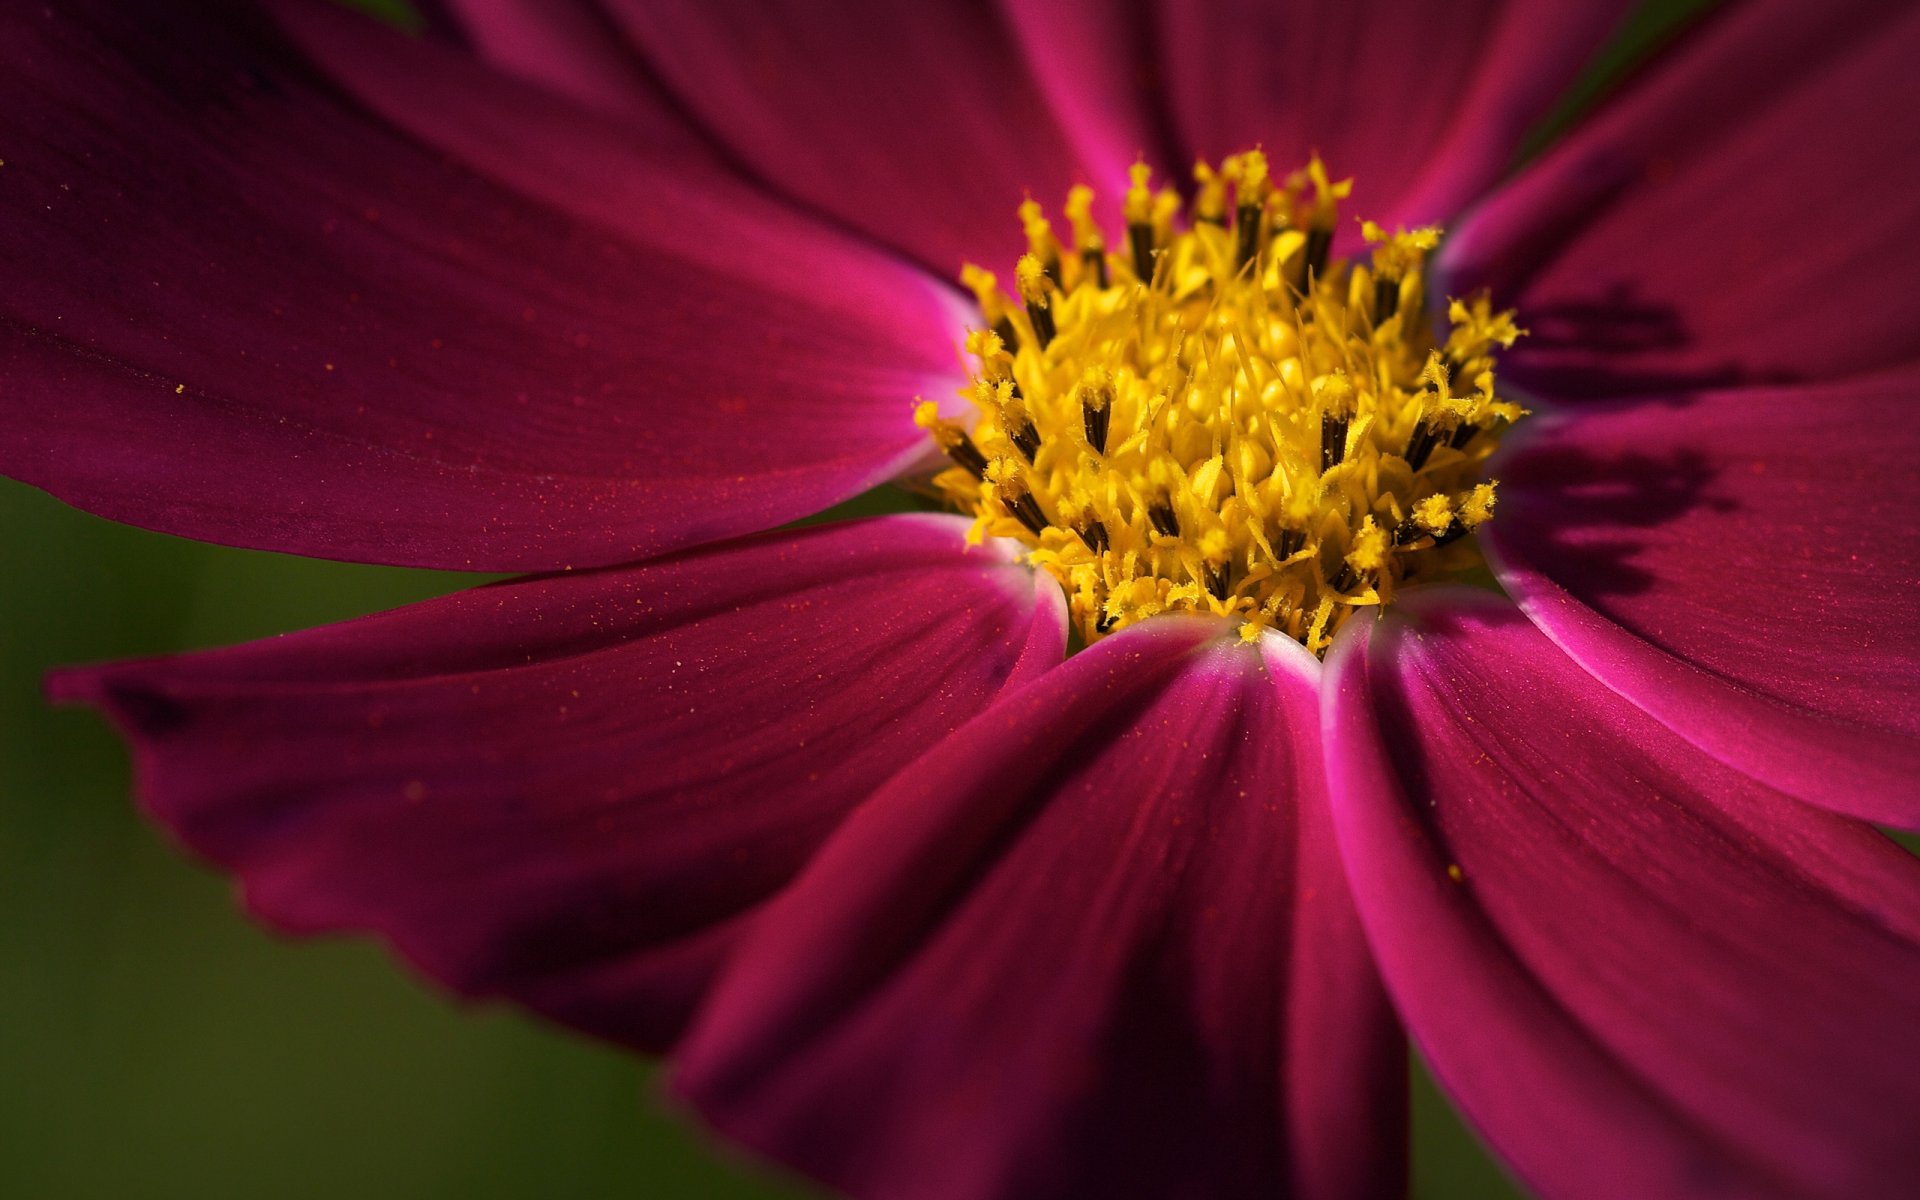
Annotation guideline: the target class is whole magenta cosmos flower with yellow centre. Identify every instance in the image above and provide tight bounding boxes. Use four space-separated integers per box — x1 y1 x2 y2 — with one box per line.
0 0 1920 1196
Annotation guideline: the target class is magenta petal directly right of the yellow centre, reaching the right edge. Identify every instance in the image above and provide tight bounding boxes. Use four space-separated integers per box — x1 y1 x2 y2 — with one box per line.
1482 371 1920 828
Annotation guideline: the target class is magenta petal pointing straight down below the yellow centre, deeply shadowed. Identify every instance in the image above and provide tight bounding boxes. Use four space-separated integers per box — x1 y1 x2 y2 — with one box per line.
678 618 1405 1200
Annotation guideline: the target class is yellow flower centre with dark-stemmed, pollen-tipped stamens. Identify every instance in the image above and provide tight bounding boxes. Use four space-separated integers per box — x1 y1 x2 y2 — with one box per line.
916 150 1524 653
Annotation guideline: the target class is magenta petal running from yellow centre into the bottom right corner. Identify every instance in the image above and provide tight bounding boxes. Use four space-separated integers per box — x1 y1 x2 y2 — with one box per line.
1327 589 1920 1200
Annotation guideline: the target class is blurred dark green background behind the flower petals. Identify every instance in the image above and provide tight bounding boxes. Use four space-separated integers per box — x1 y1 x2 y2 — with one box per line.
0 0 1743 1200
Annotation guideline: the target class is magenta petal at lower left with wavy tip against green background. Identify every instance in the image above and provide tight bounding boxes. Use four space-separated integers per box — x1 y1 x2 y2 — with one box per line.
54 516 1066 1048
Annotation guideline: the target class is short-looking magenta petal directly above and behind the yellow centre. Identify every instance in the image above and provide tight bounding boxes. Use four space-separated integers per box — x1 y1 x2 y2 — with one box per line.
1162 0 1632 234
